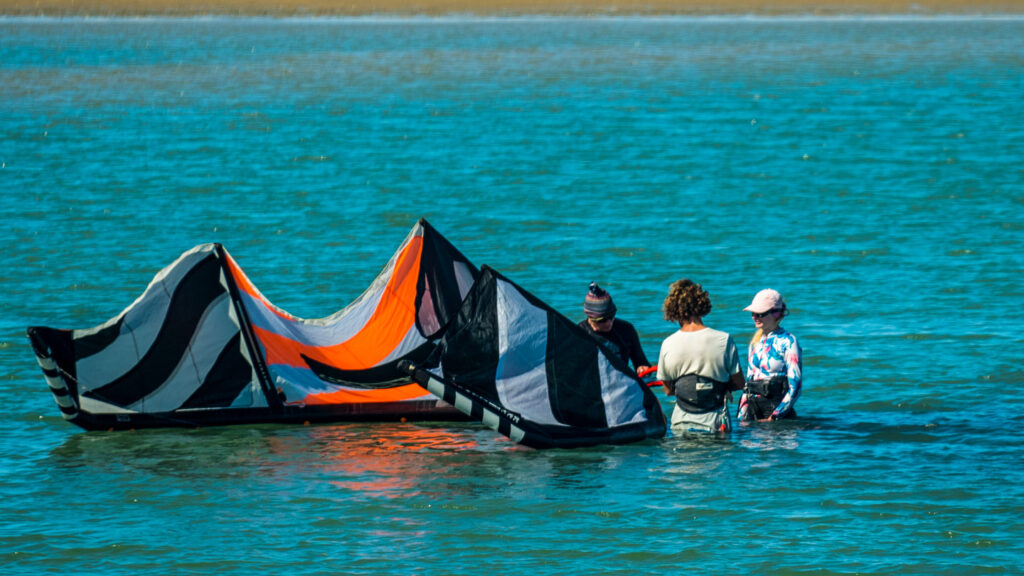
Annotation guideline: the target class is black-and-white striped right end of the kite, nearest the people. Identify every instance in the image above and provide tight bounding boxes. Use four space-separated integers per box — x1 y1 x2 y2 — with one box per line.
403 265 666 448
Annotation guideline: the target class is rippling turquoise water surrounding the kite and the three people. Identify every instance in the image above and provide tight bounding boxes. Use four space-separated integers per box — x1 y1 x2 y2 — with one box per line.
0 17 1024 575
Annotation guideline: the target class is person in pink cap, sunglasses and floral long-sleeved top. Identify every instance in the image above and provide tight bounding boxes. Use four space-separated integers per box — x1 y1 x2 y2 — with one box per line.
736 288 803 421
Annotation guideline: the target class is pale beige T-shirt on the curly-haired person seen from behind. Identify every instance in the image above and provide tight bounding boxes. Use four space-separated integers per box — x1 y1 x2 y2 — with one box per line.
657 328 739 382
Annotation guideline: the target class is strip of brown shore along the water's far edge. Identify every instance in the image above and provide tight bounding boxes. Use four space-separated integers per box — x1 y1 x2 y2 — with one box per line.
0 0 1024 17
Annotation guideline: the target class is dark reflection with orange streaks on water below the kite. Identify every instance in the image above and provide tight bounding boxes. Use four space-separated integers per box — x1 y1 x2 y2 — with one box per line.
43 422 651 498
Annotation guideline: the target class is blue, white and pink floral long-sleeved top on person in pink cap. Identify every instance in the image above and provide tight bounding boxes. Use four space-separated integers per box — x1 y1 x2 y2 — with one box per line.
738 327 804 419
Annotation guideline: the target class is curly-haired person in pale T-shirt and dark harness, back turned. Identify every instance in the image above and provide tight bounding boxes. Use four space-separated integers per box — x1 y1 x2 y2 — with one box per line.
657 278 743 433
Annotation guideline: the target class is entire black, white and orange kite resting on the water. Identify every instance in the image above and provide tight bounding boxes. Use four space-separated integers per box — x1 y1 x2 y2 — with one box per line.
28 219 666 447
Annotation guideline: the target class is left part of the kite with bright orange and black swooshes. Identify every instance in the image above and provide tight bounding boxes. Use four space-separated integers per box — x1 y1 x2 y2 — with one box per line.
28 220 478 429
